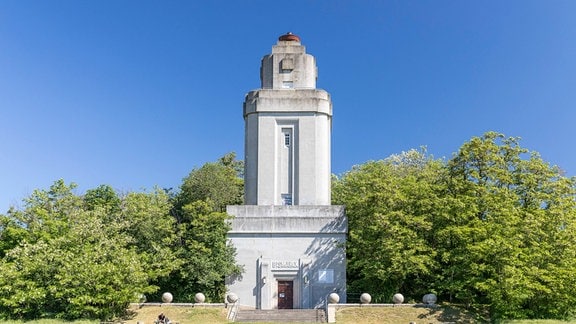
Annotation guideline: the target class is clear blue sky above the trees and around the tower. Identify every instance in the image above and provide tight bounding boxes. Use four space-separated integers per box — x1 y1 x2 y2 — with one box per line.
0 0 576 213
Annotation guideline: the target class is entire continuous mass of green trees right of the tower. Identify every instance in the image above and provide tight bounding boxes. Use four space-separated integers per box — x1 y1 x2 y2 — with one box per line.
333 132 576 318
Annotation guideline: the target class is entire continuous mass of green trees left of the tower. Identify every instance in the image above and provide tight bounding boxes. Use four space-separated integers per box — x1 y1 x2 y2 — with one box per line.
0 153 243 319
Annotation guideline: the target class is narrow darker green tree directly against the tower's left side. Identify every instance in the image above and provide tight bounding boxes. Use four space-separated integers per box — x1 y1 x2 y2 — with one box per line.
153 153 243 302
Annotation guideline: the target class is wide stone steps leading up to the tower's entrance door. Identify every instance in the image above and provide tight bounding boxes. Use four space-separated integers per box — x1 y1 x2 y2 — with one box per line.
235 309 326 323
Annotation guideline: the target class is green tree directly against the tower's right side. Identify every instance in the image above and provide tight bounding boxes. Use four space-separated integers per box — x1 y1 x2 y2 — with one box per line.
332 150 443 302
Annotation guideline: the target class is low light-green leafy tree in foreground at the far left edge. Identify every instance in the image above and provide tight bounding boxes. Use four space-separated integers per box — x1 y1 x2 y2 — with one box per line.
0 212 153 319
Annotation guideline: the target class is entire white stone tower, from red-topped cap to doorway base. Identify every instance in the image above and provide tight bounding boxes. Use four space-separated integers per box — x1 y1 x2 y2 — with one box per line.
227 33 348 309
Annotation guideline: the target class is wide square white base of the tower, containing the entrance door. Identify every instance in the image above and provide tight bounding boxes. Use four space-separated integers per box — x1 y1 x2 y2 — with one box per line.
228 205 347 309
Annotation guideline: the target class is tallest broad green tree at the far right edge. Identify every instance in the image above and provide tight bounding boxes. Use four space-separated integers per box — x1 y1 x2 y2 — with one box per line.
437 132 576 318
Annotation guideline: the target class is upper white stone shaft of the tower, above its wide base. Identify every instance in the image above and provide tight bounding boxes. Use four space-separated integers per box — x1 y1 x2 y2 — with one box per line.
244 34 332 205
